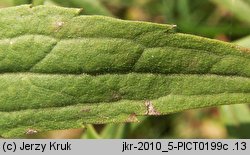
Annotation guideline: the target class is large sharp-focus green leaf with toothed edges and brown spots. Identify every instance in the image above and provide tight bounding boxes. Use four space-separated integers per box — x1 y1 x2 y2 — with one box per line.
0 5 250 137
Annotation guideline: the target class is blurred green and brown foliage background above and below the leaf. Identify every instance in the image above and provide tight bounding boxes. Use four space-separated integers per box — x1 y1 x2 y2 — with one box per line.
0 0 250 138
